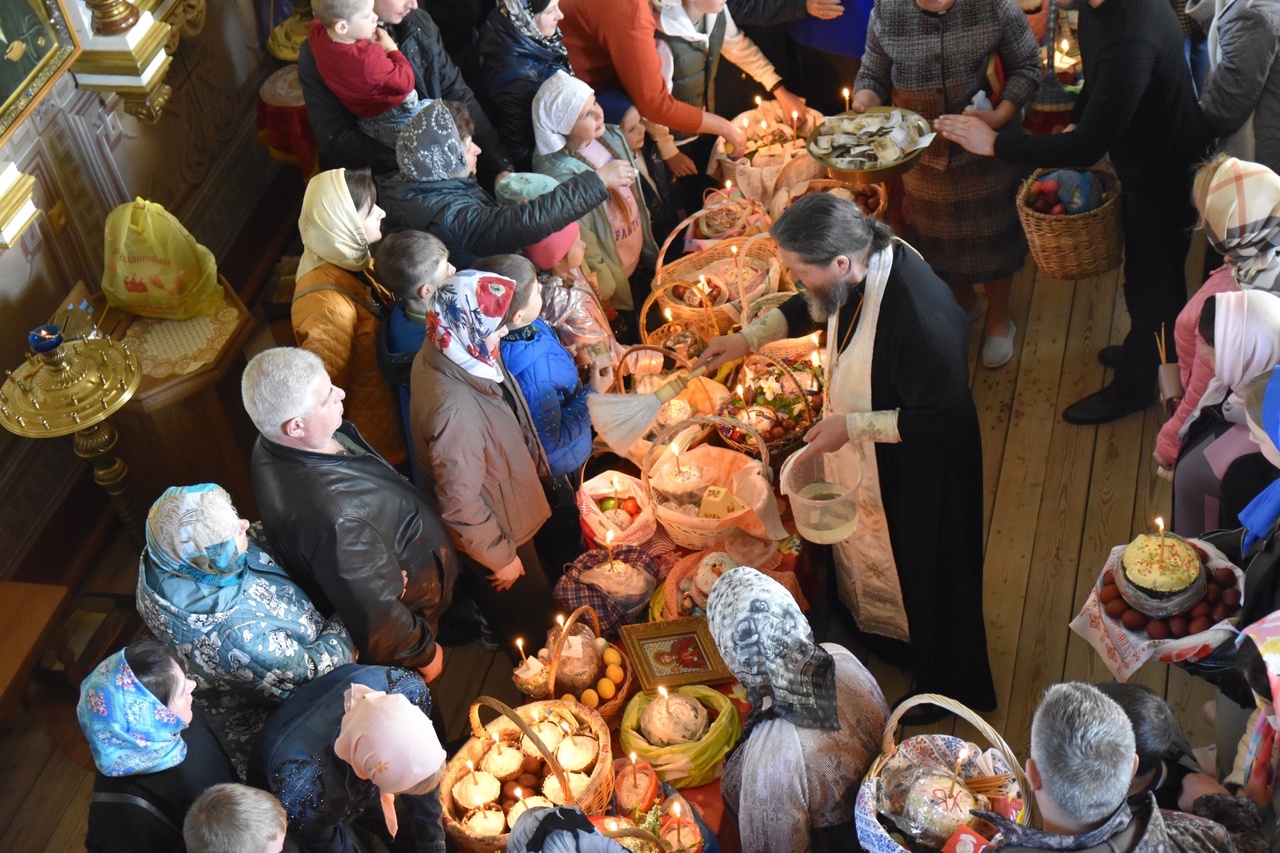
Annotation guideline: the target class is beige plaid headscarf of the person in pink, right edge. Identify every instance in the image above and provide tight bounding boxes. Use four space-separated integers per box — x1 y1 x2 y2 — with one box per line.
1196 158 1280 292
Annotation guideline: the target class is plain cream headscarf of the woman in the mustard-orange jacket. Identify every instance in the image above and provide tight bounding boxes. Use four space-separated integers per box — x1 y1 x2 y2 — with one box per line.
297 169 374 278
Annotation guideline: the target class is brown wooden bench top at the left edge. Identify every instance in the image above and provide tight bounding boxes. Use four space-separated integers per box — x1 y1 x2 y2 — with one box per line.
0 580 68 719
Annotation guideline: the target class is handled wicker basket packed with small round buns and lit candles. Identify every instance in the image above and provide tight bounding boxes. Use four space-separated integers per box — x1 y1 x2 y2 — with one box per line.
439 695 614 853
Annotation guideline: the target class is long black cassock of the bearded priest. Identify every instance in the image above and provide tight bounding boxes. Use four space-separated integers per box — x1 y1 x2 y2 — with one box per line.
780 241 996 711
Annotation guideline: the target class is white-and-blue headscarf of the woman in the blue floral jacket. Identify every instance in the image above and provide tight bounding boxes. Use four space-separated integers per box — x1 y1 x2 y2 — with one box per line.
146 483 248 587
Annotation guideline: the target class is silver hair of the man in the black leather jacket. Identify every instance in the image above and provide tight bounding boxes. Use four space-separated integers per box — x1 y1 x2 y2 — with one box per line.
241 347 328 441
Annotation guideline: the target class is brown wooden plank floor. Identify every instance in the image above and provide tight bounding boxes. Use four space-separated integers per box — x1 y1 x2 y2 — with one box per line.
0 249 1212 853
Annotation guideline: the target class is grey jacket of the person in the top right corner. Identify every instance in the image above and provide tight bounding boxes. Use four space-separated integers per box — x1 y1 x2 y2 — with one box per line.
1190 0 1280 172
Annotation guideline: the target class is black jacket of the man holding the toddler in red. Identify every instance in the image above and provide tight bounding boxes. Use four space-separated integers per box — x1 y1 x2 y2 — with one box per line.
298 9 511 174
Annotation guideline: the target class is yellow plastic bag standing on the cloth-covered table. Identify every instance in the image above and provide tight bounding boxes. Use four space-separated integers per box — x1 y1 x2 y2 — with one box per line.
102 199 223 320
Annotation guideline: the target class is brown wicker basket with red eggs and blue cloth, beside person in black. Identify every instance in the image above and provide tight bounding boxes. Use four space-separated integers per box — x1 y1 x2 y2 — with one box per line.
1016 167 1124 279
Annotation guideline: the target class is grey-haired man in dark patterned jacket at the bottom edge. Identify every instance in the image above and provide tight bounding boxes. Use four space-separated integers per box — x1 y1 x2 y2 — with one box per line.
978 681 1266 853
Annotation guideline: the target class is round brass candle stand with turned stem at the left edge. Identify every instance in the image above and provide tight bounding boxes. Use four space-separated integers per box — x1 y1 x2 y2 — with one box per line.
0 318 143 548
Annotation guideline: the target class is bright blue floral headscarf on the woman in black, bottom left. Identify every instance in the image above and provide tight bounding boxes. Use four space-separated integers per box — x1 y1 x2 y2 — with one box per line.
76 649 187 776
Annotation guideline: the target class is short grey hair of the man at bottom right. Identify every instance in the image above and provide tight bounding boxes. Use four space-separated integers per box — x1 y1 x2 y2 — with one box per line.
1030 681 1137 824
